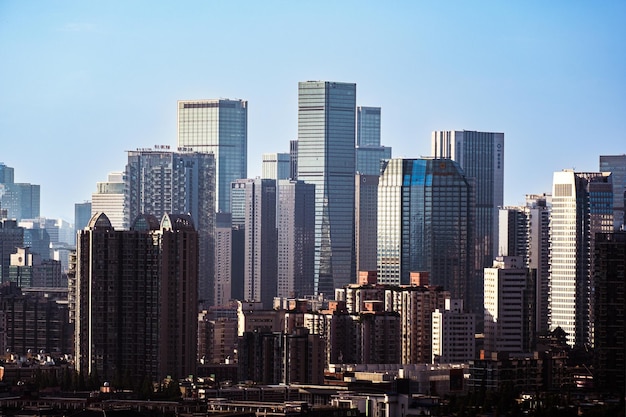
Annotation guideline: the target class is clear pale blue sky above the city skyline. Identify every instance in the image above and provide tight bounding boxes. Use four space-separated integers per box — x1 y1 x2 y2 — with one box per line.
0 0 626 221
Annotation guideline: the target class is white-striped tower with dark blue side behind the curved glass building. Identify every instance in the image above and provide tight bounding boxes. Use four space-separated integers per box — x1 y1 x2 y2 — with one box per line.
432 130 504 308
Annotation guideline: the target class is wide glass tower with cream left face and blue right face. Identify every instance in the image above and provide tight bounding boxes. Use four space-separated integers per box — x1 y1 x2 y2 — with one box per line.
178 99 248 213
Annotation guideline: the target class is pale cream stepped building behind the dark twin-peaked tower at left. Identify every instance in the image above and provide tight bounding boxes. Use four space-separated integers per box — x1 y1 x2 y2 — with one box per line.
89 172 125 230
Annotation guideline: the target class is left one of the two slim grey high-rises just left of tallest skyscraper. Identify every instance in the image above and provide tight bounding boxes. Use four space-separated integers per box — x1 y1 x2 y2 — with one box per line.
233 178 278 309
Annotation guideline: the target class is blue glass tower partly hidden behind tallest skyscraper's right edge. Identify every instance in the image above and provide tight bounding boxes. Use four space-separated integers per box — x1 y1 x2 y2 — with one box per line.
356 106 391 175
